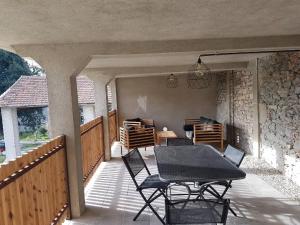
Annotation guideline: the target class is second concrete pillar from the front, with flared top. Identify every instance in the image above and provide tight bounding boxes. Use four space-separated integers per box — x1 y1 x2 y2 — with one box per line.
87 72 113 161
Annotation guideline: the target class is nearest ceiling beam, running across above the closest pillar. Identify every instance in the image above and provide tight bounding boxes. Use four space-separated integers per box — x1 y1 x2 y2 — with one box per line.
12 35 300 59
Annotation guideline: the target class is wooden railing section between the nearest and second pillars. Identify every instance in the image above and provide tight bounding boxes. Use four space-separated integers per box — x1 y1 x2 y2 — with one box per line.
80 117 104 184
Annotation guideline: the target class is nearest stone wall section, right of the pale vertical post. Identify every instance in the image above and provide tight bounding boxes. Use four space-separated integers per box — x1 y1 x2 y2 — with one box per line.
258 53 300 184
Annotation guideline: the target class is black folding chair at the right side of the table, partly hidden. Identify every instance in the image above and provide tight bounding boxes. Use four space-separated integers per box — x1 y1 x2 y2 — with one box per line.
203 145 245 216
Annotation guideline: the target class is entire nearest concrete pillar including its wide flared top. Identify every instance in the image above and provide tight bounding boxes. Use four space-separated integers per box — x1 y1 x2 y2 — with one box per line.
16 45 90 217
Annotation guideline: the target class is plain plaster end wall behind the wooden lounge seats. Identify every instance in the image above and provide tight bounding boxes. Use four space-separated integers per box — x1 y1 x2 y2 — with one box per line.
117 75 216 136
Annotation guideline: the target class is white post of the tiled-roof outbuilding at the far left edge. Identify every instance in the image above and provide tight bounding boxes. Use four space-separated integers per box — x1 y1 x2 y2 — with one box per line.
1 107 21 161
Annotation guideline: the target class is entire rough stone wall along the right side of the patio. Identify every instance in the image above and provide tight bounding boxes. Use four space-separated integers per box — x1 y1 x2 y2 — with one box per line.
217 52 300 185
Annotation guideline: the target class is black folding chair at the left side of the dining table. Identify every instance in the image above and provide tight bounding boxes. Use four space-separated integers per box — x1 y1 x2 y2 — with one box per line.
122 148 169 224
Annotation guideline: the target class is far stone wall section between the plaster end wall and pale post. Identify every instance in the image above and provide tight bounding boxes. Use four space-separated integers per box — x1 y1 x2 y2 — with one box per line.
216 70 253 153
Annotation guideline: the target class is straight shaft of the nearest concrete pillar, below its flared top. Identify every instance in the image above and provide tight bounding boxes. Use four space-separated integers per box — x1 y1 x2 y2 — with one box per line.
47 73 85 217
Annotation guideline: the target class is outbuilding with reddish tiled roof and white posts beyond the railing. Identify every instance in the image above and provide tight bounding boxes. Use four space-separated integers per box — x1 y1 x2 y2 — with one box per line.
0 76 95 158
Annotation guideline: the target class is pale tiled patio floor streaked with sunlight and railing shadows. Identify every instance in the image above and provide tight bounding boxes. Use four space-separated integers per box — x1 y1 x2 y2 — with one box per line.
67 144 300 225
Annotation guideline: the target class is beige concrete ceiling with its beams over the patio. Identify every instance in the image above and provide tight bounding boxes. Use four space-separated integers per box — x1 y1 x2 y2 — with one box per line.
0 0 300 76
